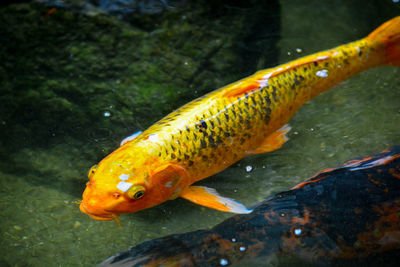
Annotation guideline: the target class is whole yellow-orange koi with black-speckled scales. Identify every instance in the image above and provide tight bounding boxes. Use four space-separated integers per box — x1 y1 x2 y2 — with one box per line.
80 17 400 220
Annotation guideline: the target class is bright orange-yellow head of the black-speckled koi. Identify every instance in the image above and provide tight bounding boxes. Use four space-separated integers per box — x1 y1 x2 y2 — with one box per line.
80 146 186 221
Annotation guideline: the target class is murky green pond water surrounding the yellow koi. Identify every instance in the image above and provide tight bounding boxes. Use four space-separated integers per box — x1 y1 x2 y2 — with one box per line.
0 0 400 266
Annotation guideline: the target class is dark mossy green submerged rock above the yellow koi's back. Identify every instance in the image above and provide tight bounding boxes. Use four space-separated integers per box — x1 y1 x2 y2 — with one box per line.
0 0 280 170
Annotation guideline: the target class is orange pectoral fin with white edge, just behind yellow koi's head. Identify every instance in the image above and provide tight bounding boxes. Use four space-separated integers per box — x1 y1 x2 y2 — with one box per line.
180 186 252 214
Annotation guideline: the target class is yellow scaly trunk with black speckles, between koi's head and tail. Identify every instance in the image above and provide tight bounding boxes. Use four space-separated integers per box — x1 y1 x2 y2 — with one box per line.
137 37 379 184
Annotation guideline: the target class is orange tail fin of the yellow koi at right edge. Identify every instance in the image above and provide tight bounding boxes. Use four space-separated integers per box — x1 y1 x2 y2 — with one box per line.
367 16 400 66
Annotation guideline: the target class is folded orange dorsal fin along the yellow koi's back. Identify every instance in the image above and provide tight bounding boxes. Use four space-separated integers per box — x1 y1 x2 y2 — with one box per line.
223 54 335 97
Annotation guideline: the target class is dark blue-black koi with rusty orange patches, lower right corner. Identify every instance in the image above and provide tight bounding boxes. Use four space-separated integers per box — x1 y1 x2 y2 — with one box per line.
100 146 400 267
